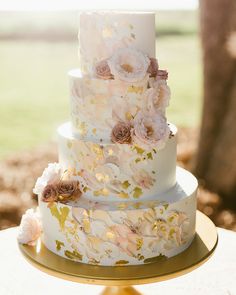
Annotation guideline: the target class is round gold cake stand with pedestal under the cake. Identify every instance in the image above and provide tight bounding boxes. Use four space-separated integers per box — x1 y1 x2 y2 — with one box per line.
19 211 218 295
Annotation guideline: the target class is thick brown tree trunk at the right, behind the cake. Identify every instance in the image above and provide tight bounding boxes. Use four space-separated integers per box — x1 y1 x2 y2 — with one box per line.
195 0 236 207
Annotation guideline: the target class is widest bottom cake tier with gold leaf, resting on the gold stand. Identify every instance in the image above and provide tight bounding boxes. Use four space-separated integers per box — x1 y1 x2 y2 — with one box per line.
39 168 197 266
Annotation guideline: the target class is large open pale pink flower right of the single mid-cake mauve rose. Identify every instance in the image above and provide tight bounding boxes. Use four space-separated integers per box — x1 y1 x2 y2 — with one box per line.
132 111 170 149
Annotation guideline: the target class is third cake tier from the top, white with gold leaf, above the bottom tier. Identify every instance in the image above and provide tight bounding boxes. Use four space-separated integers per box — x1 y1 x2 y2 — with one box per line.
58 123 177 201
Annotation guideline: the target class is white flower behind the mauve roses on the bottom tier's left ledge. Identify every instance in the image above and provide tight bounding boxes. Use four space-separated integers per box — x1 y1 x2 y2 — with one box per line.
33 163 62 195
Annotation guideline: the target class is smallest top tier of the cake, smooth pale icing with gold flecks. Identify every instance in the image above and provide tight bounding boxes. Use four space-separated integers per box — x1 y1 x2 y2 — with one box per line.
79 12 155 74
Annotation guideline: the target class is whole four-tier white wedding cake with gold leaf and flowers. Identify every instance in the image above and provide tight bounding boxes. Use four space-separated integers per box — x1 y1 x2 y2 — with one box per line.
18 12 197 266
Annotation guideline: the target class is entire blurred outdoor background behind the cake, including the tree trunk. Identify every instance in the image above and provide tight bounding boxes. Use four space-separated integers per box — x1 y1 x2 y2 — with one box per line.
0 0 236 230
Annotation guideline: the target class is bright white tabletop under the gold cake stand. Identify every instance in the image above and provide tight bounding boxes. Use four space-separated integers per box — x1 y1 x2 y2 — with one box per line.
0 228 236 295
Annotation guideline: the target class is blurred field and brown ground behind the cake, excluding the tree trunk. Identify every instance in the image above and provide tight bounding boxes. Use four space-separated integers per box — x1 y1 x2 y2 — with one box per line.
0 3 236 230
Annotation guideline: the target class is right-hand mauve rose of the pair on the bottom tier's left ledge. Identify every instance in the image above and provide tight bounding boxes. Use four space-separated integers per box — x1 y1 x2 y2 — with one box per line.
57 180 82 202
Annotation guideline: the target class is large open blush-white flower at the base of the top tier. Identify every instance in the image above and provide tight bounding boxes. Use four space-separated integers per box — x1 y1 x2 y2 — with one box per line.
108 47 150 83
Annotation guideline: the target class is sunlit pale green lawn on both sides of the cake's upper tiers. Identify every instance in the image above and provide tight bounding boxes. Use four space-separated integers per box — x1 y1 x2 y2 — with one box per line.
0 35 202 158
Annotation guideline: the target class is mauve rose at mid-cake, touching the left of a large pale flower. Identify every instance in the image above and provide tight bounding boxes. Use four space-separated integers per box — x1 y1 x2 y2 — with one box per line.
111 122 131 143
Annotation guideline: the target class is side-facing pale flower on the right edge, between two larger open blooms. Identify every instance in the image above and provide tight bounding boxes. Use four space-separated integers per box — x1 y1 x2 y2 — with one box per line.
144 80 170 114
